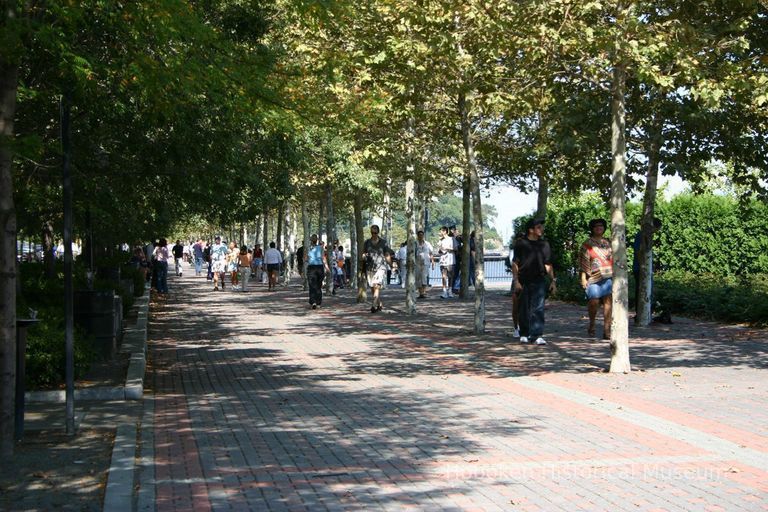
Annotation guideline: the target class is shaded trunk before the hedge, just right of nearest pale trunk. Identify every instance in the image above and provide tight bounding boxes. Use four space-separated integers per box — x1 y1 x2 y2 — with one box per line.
635 121 662 326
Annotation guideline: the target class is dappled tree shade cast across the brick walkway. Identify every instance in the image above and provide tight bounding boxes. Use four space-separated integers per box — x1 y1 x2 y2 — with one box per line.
142 272 766 510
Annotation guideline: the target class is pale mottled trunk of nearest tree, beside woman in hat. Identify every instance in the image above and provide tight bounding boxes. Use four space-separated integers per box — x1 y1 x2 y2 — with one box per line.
610 64 631 373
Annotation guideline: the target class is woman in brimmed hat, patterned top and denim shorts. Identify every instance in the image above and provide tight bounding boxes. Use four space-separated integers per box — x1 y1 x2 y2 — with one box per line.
579 219 613 339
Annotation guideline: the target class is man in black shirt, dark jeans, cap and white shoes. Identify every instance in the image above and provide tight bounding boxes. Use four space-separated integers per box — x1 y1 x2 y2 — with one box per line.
512 219 556 345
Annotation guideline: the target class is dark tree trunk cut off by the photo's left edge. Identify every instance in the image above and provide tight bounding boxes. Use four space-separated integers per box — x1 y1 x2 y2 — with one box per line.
0 50 18 461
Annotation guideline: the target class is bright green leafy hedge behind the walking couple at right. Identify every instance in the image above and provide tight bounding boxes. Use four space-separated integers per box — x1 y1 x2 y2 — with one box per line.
532 193 768 325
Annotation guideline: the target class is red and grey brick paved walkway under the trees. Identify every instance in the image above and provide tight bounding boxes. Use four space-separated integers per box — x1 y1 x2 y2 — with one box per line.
137 277 768 511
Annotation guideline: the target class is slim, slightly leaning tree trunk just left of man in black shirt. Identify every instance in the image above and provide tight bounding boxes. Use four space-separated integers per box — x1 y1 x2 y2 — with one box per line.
459 93 485 334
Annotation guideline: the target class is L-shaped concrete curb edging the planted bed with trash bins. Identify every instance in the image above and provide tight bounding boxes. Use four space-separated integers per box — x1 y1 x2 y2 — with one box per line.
24 290 149 403
